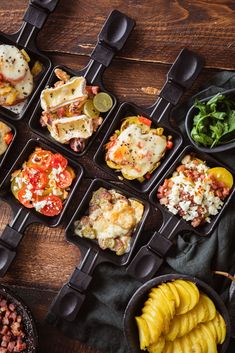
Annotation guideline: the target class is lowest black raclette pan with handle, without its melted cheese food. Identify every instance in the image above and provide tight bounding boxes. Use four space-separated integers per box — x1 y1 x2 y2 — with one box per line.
47 179 150 323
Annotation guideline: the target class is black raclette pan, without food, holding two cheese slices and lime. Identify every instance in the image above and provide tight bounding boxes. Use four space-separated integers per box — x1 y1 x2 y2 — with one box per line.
29 10 135 157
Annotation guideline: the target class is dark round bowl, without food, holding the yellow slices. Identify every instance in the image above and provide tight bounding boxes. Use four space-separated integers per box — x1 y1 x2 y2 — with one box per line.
123 274 231 353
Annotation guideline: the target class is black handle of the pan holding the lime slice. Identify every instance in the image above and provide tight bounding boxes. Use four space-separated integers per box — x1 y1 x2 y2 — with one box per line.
84 10 135 83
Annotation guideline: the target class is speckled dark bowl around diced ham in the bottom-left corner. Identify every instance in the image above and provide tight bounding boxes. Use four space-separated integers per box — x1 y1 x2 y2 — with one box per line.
0 285 38 353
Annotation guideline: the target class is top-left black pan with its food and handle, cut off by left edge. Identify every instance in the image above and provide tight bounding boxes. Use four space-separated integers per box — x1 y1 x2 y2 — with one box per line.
0 0 59 120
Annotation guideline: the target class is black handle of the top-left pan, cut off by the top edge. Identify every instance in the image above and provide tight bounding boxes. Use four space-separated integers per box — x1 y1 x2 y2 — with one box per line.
12 0 59 50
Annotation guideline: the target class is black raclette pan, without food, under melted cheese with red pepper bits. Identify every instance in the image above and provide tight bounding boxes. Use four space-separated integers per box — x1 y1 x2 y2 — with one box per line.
94 49 203 193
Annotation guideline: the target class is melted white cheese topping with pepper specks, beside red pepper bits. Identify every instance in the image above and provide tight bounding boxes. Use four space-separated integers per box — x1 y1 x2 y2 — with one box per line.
107 124 166 179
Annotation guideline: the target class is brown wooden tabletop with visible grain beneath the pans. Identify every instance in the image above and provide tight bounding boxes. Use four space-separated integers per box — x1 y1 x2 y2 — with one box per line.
0 0 235 353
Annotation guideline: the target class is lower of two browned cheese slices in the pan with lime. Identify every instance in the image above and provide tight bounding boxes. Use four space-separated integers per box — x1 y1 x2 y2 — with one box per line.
48 115 93 143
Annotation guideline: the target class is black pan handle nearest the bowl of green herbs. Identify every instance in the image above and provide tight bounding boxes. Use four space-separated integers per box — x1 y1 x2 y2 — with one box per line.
148 48 204 123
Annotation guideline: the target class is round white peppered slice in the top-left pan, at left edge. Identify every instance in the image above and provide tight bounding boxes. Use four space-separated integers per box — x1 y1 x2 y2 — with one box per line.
0 44 29 83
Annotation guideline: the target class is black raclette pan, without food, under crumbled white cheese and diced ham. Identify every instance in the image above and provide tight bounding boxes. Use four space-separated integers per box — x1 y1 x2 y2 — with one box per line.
127 146 235 282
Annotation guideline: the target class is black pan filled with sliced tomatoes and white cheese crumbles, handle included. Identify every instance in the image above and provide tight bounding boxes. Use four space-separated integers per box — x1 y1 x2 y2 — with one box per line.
0 139 83 276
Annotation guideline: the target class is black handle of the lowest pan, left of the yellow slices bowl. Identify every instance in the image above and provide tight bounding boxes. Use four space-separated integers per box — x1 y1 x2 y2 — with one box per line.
46 249 100 324
